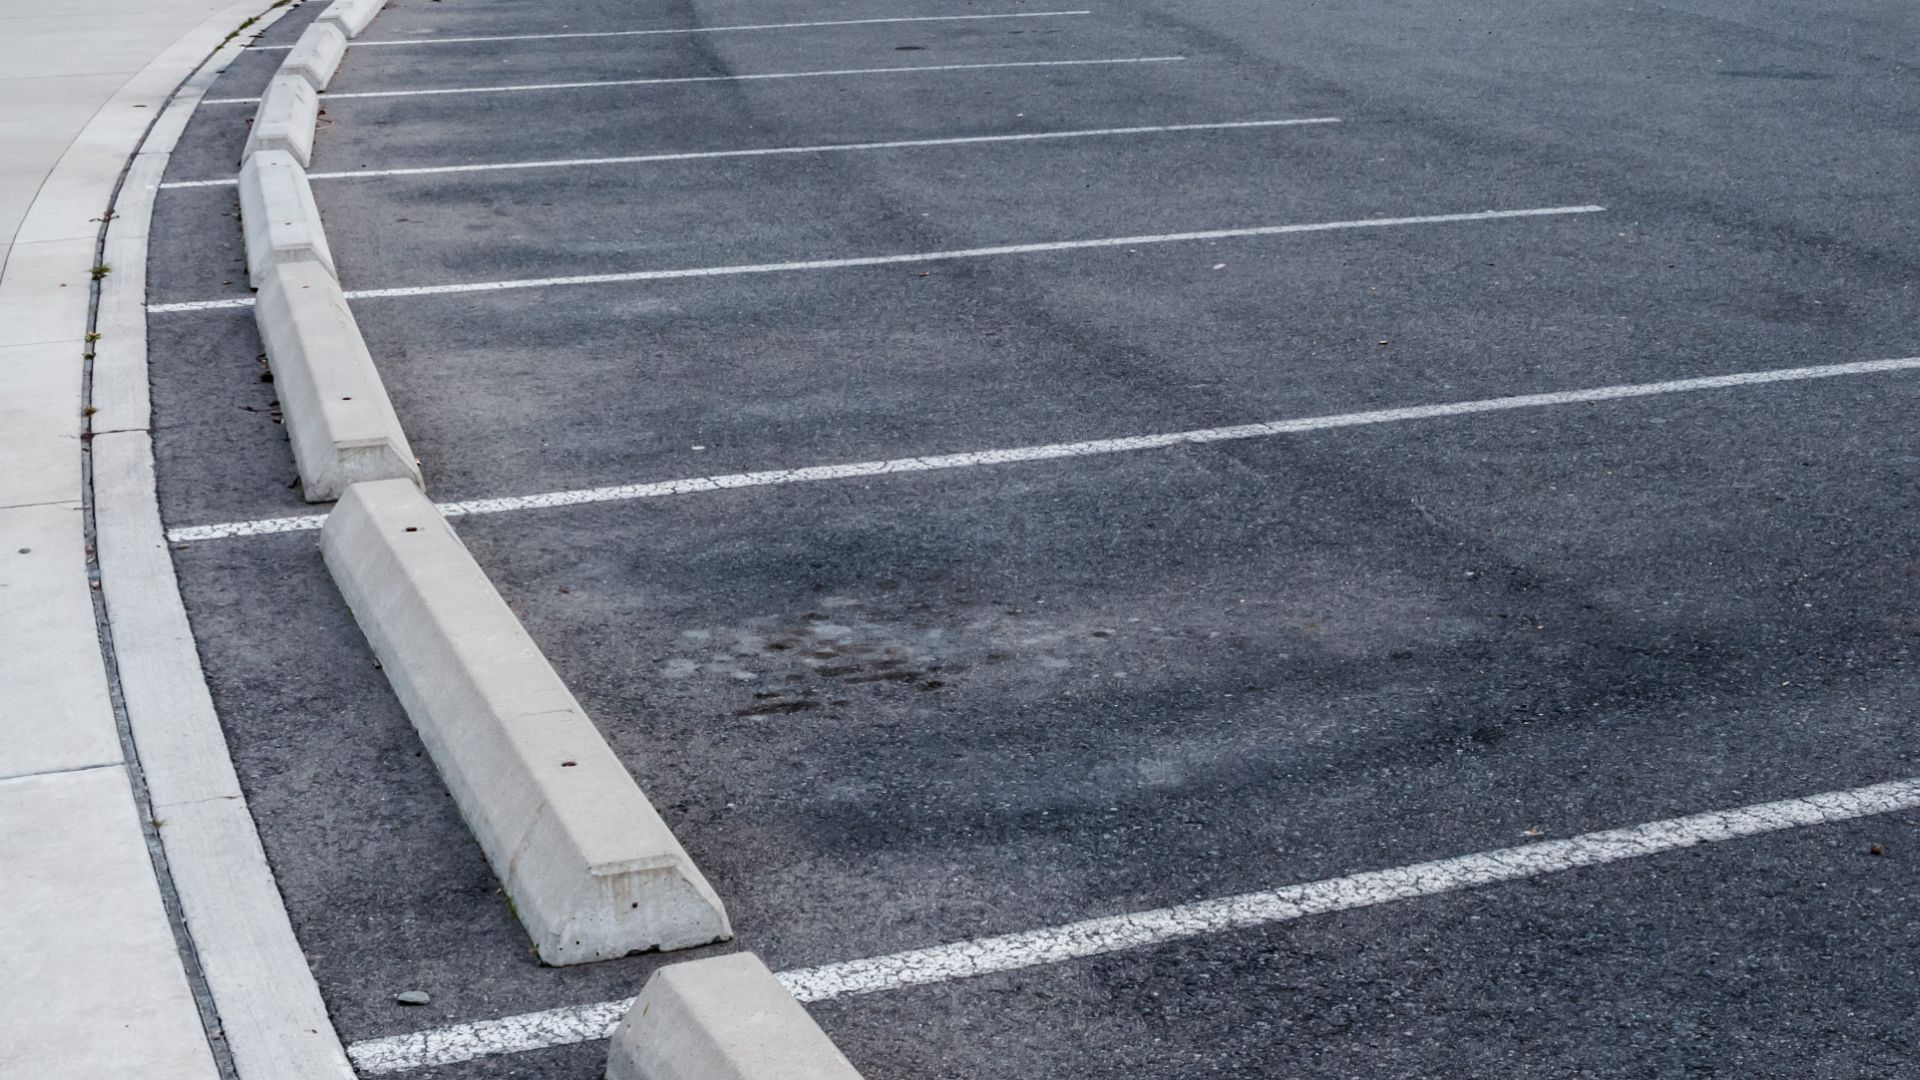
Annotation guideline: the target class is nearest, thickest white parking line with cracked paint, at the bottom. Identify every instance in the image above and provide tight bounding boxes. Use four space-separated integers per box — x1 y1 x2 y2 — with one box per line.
348 780 1920 1076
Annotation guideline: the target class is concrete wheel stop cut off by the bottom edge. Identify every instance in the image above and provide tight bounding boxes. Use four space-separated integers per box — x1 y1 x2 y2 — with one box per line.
607 953 860 1080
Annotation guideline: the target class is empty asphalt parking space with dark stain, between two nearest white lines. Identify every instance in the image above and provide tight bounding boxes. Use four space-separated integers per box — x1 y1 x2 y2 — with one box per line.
165 388 1912 1036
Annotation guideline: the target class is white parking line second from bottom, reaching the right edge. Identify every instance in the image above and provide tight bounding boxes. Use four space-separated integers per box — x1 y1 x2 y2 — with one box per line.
167 356 1920 544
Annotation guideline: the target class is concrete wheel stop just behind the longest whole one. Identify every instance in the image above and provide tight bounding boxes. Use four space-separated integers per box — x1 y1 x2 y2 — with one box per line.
253 261 424 502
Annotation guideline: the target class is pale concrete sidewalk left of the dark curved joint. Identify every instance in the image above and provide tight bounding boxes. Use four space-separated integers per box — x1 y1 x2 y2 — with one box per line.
0 0 291 1080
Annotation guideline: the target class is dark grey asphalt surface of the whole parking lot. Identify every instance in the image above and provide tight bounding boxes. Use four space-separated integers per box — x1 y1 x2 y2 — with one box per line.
150 0 1920 1080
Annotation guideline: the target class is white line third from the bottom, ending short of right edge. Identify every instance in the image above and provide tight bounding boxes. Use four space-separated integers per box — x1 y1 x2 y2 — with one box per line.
148 206 1607 315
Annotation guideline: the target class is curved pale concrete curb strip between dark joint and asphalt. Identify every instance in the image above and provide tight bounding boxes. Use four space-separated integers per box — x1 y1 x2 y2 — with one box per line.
88 0 353 1080
